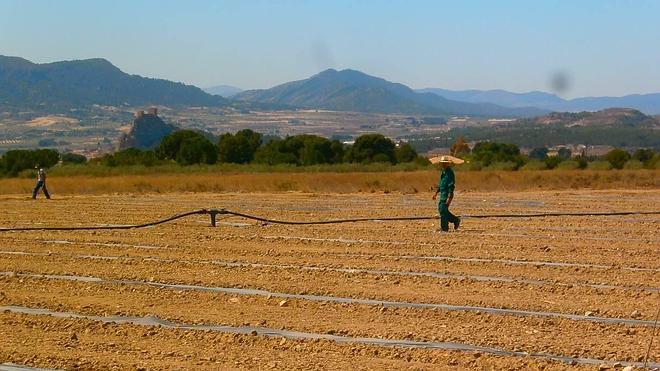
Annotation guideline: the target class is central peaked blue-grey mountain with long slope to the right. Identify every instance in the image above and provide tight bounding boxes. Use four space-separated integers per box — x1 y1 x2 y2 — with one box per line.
233 69 548 117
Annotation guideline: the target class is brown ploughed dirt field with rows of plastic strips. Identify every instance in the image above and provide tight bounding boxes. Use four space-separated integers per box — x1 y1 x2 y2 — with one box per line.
0 190 660 370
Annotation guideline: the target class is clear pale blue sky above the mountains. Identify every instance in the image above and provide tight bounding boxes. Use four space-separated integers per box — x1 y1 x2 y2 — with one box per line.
0 0 660 97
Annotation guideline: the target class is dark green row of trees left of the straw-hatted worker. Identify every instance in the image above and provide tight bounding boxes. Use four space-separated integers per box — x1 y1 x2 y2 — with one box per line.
0 129 428 176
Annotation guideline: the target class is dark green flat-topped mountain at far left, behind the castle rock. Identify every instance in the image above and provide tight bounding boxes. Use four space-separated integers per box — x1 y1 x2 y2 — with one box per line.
0 56 227 110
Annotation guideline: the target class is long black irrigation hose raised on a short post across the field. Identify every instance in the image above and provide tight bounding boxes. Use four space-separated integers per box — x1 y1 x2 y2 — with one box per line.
0 209 660 232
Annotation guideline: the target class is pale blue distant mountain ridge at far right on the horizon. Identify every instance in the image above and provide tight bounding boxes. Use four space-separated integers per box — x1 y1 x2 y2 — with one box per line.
416 88 660 115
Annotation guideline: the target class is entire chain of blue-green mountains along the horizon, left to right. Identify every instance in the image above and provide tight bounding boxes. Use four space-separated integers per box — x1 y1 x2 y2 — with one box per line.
0 56 660 117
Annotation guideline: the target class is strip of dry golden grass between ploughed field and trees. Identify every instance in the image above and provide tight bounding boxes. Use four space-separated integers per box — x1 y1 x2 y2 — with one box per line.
0 170 660 194
